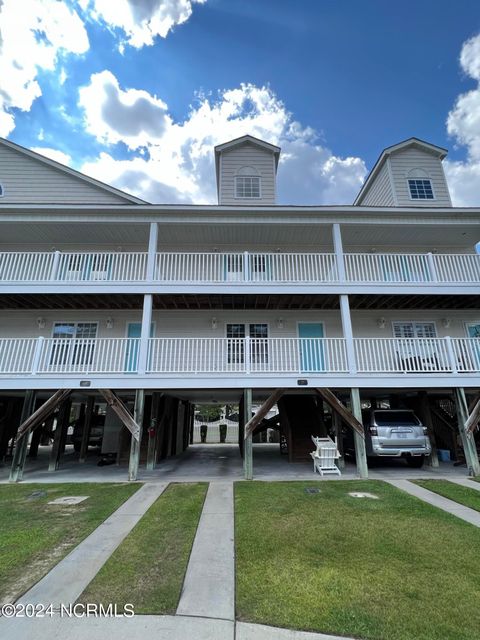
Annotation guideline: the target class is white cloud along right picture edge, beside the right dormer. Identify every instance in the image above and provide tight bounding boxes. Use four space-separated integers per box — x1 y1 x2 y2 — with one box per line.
444 35 480 206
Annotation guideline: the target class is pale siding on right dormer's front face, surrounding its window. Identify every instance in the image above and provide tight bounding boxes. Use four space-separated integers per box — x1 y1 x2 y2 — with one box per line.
388 148 452 207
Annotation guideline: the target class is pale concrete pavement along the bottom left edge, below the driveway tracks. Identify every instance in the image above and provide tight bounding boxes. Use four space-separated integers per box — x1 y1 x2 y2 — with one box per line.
0 616 235 640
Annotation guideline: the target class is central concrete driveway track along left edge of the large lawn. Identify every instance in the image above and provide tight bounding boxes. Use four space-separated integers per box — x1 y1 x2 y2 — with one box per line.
177 482 235 620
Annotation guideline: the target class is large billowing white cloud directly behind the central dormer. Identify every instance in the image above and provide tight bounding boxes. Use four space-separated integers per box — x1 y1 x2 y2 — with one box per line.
81 76 366 204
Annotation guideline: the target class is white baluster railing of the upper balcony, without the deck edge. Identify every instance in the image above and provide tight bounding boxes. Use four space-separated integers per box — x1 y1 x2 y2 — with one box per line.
0 251 480 285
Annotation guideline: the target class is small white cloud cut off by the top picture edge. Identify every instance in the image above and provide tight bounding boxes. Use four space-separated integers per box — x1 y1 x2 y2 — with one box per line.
79 0 206 48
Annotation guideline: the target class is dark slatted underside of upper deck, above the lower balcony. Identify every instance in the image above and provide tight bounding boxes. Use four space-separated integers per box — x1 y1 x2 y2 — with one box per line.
0 294 480 310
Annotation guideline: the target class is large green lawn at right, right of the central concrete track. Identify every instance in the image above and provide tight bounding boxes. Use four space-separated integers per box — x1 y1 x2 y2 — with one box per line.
235 480 480 640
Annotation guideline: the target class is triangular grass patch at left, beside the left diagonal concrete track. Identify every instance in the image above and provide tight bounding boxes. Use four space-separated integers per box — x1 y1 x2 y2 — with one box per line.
0 483 140 602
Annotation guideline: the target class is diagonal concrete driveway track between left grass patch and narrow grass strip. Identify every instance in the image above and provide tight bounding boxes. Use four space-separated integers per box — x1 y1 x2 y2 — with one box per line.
18 483 168 608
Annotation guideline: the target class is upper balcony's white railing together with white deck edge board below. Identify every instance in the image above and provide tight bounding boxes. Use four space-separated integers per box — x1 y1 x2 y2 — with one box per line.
0 251 480 293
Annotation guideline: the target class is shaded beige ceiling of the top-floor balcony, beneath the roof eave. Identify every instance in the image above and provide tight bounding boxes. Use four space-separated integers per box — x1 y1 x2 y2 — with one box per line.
0 220 480 253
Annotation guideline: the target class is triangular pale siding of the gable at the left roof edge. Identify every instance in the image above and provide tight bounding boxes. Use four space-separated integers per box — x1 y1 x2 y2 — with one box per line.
0 144 131 204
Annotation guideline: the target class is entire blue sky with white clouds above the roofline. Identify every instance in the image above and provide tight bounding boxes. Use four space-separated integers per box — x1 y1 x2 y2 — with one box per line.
0 0 480 206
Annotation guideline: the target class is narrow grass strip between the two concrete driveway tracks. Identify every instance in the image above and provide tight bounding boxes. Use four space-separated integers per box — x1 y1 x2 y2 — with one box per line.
79 483 208 614
